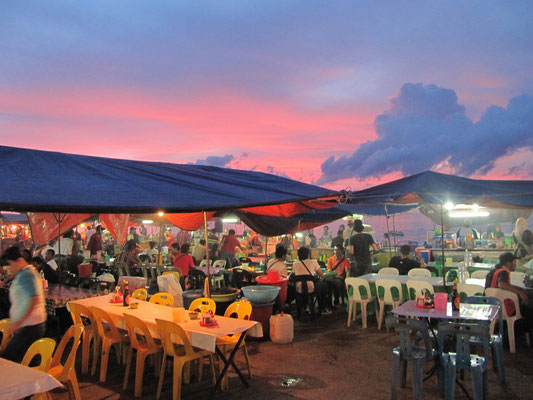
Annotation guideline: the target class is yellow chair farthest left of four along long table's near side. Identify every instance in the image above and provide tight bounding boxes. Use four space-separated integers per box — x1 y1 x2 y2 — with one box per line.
68 303 99 375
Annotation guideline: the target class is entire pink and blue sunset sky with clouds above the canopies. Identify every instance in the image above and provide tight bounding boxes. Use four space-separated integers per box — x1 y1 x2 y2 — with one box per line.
0 0 533 241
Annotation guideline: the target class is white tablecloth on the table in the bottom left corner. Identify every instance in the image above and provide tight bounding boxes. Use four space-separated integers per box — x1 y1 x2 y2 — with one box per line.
0 358 62 400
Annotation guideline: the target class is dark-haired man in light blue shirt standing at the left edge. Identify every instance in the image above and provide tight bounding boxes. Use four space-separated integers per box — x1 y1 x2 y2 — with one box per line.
0 246 46 362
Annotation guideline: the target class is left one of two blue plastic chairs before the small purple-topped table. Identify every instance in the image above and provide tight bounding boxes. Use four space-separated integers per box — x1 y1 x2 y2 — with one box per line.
385 315 436 400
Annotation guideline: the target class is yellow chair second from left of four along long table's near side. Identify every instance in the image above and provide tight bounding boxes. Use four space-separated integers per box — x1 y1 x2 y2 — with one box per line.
89 306 129 382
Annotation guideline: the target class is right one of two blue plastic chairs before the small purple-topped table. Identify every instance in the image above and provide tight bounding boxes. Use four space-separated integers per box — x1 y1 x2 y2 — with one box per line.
438 322 489 400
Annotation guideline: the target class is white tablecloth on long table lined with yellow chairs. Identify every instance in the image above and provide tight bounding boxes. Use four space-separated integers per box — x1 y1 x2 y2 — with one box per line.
68 295 263 352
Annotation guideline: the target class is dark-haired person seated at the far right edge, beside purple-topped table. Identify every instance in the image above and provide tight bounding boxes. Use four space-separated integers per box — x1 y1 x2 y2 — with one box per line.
485 252 533 330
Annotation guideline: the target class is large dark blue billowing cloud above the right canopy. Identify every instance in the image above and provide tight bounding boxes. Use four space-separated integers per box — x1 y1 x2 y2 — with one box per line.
318 83 533 184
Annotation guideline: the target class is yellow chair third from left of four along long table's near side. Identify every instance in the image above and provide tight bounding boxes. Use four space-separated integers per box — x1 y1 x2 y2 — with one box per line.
122 314 162 397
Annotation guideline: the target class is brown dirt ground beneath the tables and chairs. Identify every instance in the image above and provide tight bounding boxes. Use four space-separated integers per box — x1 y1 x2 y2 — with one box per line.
53 308 533 400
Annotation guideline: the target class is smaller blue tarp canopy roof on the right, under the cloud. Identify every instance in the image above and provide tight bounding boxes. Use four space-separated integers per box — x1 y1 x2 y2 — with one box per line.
349 171 533 208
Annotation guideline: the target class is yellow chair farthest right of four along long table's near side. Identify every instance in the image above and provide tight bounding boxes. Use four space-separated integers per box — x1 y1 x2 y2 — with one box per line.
155 319 216 400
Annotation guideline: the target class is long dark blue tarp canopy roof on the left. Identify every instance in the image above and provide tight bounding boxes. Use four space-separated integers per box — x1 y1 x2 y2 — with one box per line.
0 146 338 213
